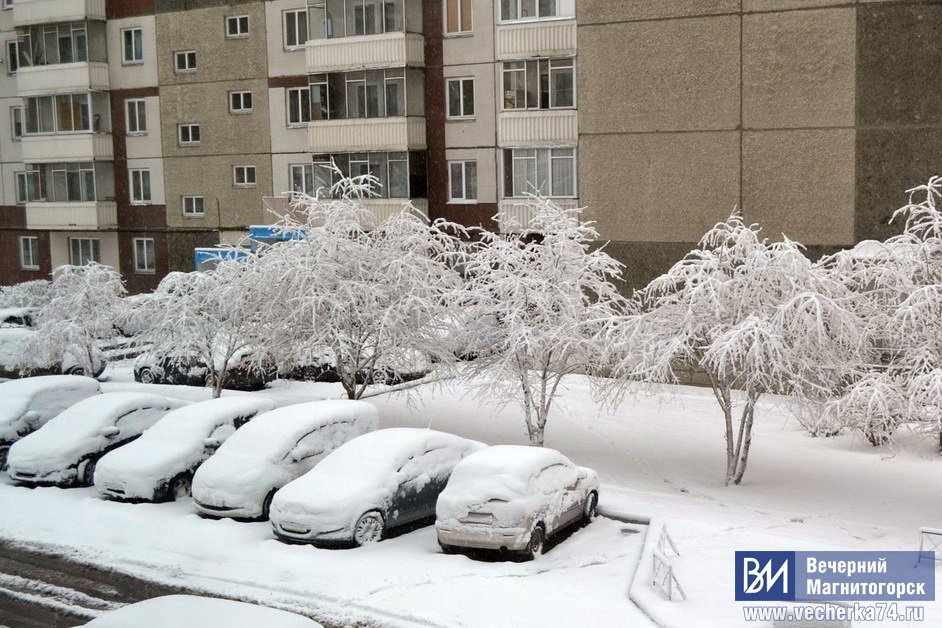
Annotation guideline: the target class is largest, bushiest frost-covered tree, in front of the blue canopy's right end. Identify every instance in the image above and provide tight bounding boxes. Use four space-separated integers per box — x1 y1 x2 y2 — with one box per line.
258 171 462 399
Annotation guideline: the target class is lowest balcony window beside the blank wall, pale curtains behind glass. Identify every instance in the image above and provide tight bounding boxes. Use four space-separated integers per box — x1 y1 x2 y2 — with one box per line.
504 148 576 197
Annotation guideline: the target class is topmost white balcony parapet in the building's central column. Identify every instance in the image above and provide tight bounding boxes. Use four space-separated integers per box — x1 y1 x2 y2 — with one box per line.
306 33 425 74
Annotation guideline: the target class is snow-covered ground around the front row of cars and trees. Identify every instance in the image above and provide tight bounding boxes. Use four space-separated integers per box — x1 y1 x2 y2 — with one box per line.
0 360 942 626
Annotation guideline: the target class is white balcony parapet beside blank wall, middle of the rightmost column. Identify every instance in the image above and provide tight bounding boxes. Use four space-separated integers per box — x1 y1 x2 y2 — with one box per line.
497 109 579 148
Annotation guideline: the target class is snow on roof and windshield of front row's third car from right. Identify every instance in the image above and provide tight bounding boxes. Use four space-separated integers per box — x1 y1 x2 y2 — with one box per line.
219 399 377 461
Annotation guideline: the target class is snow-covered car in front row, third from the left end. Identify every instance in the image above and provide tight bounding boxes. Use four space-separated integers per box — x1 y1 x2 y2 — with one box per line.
95 396 275 501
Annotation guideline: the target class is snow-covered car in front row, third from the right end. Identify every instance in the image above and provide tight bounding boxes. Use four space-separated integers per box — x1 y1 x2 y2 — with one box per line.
193 400 378 519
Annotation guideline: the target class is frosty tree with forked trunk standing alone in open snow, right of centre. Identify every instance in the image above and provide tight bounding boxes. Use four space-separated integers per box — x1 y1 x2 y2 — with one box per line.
609 213 863 485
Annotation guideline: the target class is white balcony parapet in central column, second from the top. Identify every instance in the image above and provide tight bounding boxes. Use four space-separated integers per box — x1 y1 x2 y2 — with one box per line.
310 117 425 153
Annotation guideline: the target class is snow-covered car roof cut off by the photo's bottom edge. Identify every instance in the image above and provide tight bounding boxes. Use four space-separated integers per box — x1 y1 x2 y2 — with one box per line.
85 595 322 628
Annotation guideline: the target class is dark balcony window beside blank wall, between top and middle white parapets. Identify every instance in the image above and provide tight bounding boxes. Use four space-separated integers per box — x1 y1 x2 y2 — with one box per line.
503 58 576 109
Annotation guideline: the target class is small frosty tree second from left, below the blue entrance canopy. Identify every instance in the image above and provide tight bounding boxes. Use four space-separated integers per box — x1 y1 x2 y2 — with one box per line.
130 260 266 397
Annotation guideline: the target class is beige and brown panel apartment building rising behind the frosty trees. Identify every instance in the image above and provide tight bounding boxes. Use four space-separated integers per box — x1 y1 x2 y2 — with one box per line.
0 0 942 291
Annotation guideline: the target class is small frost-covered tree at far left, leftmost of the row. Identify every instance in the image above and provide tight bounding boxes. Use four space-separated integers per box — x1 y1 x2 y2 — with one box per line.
19 263 126 375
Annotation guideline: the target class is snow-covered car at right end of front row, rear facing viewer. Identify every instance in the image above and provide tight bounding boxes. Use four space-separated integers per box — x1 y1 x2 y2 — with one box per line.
435 445 599 558
